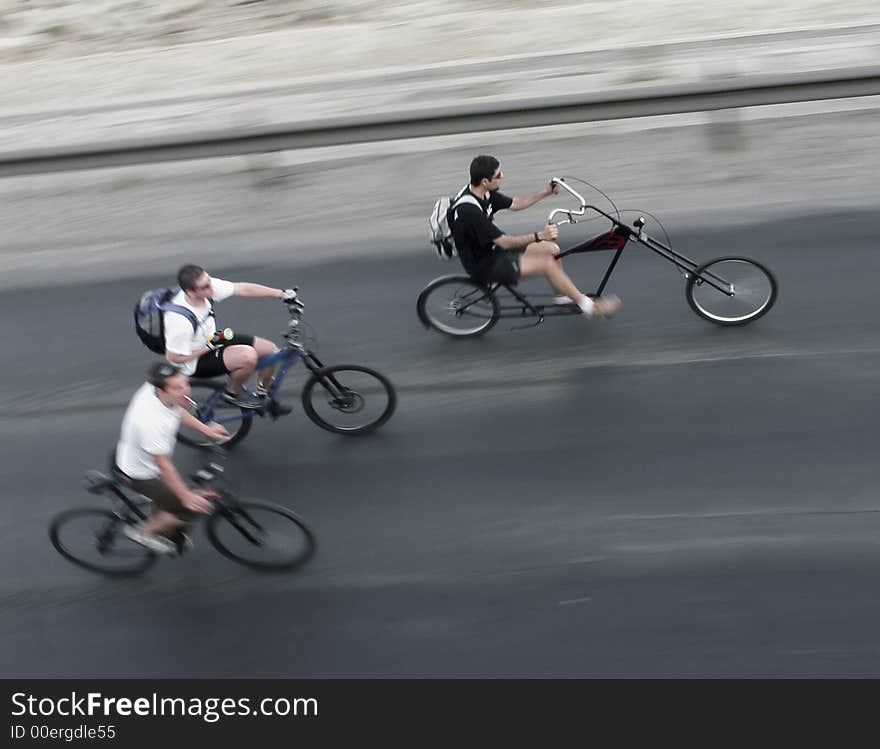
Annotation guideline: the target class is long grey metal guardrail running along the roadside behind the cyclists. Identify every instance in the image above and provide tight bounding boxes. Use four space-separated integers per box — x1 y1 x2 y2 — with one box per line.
0 66 880 177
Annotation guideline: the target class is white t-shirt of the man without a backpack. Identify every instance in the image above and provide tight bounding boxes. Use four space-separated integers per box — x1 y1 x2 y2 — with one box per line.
116 382 182 479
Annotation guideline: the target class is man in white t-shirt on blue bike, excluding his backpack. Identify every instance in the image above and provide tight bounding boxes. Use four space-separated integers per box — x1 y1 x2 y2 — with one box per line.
164 265 296 413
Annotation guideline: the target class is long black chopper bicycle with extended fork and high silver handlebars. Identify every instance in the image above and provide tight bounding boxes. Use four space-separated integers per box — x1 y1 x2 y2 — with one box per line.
416 177 778 338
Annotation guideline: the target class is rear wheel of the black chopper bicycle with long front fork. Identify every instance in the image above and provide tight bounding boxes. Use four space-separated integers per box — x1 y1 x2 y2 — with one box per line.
416 276 501 338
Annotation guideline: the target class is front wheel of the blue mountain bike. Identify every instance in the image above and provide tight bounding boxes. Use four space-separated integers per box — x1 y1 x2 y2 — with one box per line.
302 364 397 434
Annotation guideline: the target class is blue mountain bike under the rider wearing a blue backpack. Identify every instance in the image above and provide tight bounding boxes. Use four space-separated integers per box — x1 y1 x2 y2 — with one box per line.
177 298 397 448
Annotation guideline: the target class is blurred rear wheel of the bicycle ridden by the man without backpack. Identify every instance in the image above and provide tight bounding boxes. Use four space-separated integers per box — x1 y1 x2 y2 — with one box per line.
49 507 156 577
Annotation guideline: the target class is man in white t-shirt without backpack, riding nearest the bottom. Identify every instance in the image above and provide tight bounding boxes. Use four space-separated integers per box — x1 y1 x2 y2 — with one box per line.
115 361 229 554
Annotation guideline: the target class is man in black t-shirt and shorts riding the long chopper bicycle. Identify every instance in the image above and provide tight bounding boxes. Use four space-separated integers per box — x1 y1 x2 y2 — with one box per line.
440 155 620 318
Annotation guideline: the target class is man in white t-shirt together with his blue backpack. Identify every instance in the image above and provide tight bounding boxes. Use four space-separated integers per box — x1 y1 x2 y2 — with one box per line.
135 265 296 414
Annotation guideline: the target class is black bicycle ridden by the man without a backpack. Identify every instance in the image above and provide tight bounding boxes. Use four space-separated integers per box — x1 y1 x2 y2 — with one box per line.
49 447 315 577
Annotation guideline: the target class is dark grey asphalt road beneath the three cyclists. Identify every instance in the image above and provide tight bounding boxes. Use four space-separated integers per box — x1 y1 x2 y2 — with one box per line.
0 207 880 677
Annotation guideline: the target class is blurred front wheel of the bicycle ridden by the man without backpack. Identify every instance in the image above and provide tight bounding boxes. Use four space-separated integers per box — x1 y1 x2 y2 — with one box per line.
206 502 315 570
